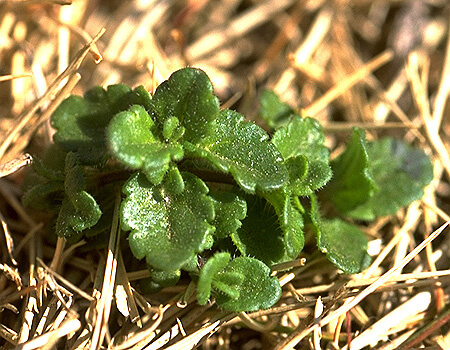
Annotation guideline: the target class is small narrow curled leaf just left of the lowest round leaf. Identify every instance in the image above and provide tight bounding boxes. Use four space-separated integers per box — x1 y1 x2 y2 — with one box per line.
197 253 231 305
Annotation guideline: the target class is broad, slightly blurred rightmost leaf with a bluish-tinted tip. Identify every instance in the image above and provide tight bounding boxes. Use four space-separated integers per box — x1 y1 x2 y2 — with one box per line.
346 138 433 220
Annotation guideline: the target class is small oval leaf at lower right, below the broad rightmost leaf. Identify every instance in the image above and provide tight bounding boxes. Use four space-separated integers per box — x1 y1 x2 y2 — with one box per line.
312 205 371 274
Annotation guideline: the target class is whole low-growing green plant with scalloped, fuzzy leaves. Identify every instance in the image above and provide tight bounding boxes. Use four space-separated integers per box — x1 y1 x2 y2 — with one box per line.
24 68 432 311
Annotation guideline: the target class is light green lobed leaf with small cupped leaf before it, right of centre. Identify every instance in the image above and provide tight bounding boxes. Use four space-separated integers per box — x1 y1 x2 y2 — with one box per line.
272 116 332 196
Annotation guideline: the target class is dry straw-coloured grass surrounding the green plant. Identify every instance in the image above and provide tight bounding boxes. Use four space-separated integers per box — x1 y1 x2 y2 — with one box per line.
0 0 450 350
